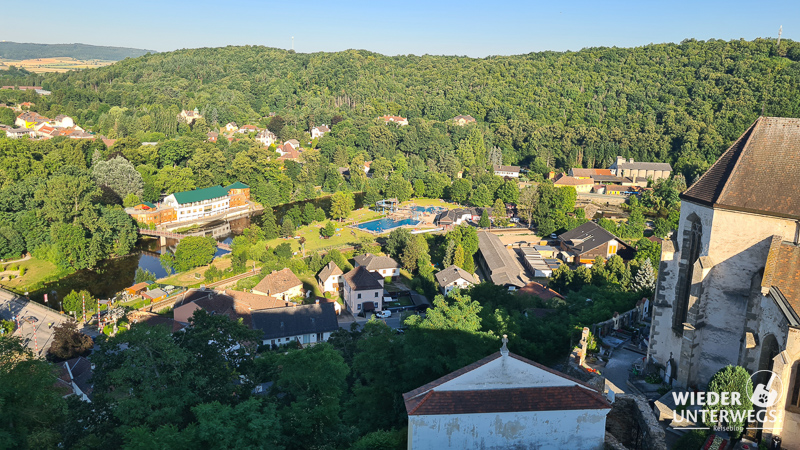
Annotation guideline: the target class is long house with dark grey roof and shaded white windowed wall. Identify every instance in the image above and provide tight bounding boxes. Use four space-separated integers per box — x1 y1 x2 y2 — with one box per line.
252 302 339 347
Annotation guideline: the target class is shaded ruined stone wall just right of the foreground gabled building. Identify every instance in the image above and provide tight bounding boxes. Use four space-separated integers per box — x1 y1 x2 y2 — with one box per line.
606 394 667 450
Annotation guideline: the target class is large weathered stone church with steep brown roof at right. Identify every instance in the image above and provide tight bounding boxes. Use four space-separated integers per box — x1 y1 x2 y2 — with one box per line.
648 117 800 448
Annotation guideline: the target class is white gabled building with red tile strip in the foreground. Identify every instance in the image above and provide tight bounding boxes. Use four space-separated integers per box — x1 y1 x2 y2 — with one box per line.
403 337 611 450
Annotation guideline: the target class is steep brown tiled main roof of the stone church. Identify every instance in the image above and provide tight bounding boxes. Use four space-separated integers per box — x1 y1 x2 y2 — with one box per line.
681 117 800 219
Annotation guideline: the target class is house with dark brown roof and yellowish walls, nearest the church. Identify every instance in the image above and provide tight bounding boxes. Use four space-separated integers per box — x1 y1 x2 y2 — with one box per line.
558 222 627 264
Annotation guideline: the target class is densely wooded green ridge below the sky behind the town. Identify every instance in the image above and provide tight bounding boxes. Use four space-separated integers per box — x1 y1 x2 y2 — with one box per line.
25 40 800 178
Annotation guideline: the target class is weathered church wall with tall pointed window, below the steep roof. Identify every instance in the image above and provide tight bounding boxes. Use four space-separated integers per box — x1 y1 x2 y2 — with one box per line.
649 202 796 387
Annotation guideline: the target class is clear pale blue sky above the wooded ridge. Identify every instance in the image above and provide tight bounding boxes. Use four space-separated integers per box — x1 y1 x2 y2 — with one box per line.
0 0 800 57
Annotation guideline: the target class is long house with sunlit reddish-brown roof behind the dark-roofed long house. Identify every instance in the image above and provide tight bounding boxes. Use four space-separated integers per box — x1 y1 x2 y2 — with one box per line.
173 288 287 327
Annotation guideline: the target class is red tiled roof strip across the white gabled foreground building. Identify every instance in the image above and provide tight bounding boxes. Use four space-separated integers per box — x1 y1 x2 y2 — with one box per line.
408 386 611 416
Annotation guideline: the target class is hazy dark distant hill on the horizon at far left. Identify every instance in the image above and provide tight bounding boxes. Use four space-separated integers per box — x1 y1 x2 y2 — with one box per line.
0 42 156 61
